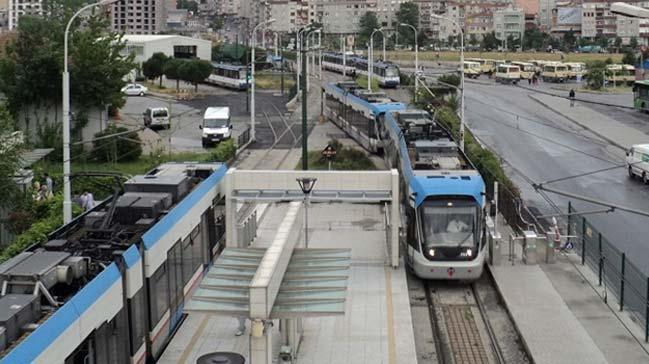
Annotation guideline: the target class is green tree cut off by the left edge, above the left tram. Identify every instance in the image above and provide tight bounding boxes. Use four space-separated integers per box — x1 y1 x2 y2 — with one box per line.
0 105 24 208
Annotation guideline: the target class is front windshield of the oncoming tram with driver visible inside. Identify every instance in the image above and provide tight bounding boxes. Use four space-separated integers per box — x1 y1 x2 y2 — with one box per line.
420 201 479 248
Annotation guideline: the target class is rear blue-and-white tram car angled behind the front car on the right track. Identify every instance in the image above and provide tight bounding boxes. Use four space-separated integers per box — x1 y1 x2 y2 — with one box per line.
323 82 405 154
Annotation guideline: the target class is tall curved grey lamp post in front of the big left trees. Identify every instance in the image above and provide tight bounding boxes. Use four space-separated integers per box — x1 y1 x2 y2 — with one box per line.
61 0 119 224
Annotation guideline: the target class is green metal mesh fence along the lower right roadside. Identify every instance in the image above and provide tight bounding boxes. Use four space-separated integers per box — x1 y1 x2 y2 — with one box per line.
568 203 649 342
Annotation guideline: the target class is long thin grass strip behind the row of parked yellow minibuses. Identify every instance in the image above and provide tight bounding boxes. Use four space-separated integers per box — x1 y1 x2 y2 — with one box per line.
386 51 623 63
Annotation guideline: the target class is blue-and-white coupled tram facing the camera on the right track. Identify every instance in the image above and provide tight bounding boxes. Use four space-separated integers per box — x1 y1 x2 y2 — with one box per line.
324 84 487 280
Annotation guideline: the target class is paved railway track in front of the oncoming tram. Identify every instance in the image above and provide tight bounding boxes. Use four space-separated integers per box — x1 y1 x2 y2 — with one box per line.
424 271 531 364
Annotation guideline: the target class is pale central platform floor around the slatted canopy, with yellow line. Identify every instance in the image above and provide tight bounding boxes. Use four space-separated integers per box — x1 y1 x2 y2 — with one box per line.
159 203 417 364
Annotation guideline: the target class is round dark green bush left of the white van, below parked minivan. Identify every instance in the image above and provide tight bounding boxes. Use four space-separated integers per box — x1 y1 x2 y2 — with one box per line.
92 125 142 163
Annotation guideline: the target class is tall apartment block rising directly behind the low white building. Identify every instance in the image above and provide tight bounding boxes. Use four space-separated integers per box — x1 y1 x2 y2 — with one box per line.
110 0 167 34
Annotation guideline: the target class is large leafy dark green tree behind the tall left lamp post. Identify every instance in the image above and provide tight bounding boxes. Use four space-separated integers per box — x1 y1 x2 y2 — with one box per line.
0 4 135 146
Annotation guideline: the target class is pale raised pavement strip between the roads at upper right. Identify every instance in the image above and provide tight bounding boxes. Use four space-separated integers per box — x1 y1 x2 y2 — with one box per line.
529 94 649 151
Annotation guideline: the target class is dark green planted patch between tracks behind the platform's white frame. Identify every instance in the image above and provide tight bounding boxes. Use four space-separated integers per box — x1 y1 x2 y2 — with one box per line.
295 140 376 171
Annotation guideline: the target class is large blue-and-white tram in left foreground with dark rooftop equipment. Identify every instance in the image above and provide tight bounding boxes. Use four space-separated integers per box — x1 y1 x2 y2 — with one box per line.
0 163 227 364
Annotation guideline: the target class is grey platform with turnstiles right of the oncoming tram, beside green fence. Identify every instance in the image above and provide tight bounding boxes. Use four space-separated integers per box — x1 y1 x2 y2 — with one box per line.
489 222 649 364
